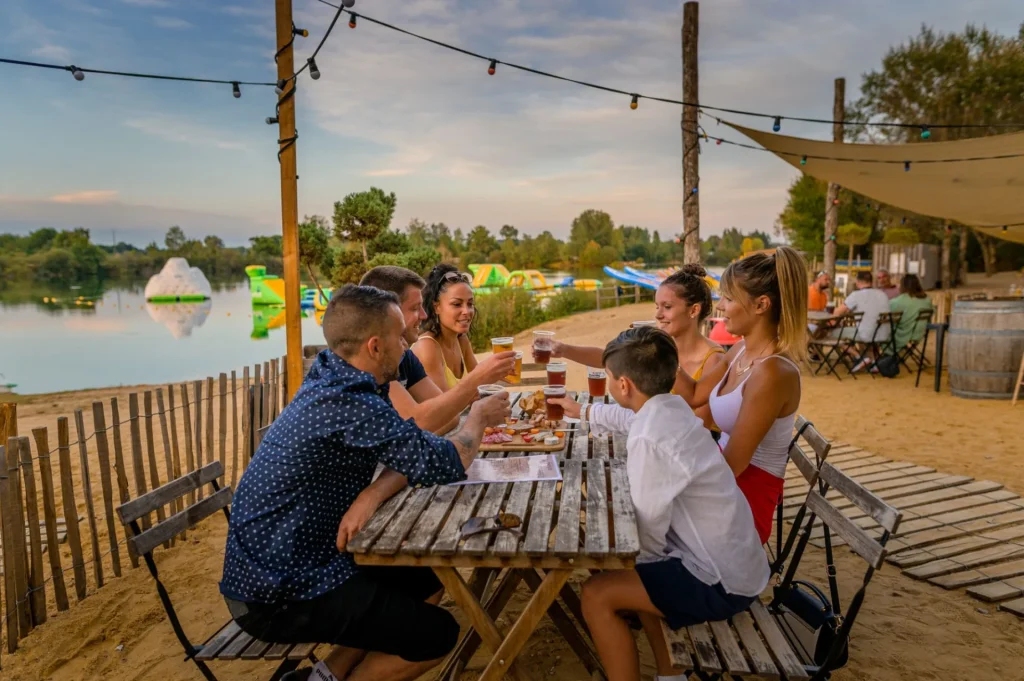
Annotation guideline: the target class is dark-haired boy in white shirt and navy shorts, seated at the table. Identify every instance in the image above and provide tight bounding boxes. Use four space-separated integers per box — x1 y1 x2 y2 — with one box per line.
562 327 769 681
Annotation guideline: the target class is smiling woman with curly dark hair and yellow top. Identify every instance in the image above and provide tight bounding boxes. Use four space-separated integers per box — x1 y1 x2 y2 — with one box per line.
413 262 477 392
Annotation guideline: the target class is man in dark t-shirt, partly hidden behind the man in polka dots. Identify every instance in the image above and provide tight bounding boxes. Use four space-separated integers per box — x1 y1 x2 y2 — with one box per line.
359 265 515 433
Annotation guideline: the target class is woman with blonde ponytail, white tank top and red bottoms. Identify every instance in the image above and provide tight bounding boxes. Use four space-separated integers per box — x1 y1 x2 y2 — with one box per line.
676 247 807 541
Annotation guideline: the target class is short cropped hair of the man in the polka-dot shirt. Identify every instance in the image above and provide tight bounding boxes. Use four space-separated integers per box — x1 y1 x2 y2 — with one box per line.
324 284 398 359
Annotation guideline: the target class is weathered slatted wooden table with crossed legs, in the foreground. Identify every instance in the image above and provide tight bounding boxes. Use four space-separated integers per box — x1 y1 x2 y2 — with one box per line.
347 393 640 681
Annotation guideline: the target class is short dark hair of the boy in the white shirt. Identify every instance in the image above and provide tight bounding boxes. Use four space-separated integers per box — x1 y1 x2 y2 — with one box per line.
601 327 679 397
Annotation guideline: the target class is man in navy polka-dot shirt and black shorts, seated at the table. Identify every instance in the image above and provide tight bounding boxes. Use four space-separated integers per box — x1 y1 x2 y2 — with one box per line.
220 286 509 680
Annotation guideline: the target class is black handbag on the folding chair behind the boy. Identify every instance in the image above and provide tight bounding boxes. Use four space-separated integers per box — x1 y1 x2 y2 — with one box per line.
772 580 849 671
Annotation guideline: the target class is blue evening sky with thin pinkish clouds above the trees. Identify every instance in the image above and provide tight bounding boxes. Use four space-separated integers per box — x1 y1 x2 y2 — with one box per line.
0 0 1024 246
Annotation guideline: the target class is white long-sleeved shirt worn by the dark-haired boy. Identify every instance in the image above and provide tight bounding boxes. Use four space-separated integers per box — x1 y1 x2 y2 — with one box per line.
590 394 769 596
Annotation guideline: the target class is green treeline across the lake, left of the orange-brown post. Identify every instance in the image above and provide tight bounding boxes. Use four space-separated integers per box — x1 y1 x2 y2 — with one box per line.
0 226 282 287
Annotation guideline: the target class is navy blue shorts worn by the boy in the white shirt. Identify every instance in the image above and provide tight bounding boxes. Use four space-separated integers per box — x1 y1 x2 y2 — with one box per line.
636 558 757 629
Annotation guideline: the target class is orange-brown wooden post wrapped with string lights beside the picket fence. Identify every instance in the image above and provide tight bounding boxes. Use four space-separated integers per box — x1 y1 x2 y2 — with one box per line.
275 0 303 399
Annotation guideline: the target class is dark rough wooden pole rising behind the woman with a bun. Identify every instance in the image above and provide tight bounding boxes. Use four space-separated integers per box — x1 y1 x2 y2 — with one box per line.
682 2 700 263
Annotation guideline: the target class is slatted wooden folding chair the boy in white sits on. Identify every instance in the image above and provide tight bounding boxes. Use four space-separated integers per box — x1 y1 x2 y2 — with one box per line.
662 431 901 680
